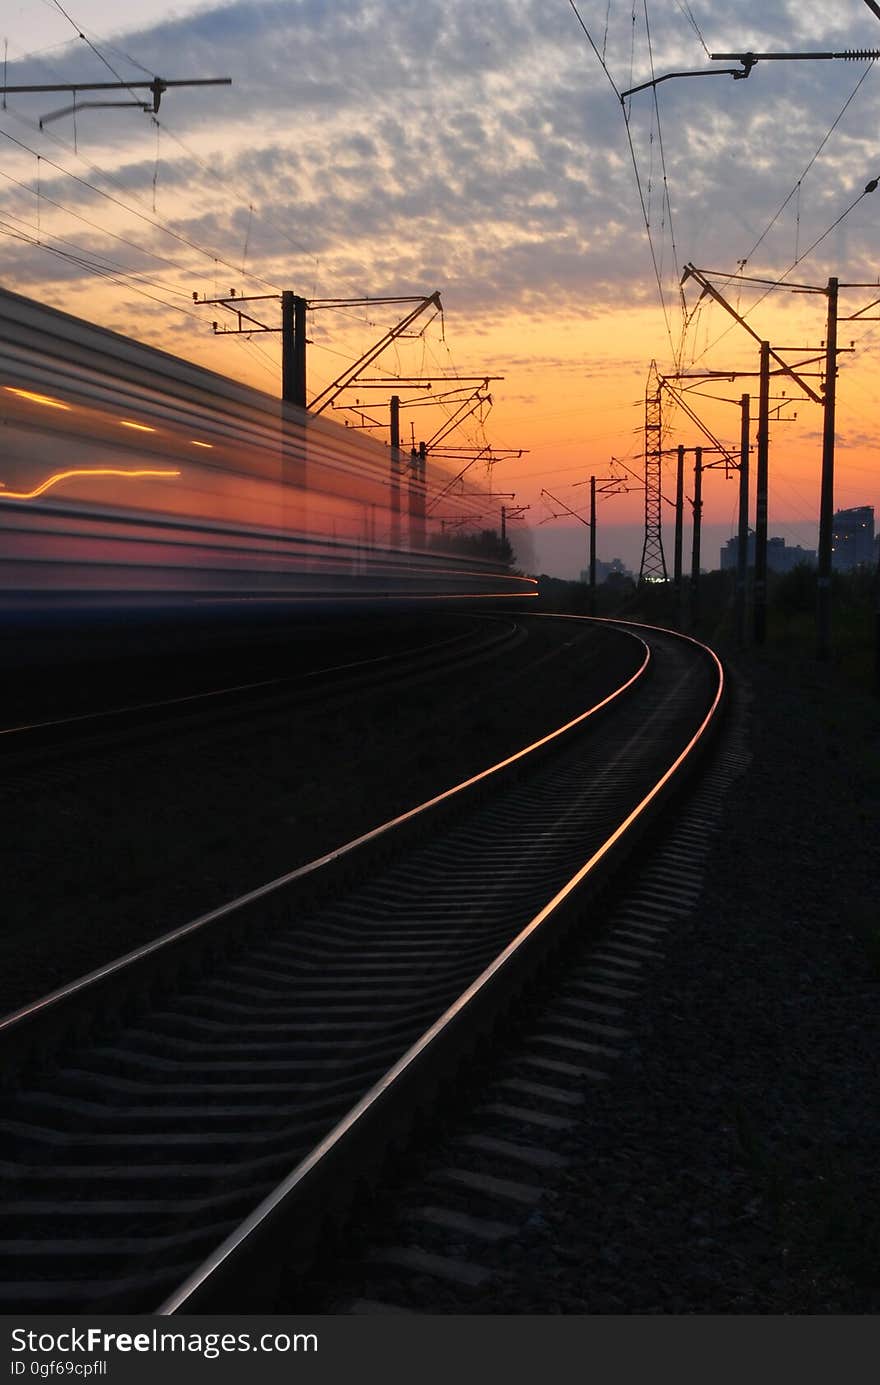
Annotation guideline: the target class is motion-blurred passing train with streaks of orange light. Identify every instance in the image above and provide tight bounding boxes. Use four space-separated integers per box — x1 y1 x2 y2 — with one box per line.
0 289 536 625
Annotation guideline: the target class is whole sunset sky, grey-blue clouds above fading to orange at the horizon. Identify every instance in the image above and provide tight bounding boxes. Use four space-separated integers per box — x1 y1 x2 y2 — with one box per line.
0 0 880 576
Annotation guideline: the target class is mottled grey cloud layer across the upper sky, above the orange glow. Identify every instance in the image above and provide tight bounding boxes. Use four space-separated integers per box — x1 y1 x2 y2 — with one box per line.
0 0 880 331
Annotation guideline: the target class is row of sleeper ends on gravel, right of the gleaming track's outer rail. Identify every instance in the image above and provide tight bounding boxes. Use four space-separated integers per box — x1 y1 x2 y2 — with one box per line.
320 698 751 1316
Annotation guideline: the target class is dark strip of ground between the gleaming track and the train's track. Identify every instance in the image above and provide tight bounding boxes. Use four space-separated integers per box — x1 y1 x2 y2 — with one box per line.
0 615 623 1015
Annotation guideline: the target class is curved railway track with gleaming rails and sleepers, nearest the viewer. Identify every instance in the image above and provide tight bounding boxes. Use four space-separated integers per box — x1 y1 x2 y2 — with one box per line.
0 617 722 1312
